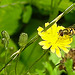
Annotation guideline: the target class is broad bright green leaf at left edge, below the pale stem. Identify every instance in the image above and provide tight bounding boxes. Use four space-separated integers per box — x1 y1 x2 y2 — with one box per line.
0 5 22 35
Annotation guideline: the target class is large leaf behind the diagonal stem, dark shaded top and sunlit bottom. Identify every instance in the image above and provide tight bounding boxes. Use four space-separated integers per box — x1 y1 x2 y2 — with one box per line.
21 19 45 72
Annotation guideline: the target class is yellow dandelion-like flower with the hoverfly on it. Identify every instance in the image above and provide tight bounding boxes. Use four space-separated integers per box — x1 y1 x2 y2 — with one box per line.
37 23 72 57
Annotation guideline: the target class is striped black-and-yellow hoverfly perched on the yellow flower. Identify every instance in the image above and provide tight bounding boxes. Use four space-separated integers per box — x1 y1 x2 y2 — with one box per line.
59 24 75 36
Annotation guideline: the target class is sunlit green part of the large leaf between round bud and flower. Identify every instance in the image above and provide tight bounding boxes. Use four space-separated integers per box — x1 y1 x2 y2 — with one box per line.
21 33 45 72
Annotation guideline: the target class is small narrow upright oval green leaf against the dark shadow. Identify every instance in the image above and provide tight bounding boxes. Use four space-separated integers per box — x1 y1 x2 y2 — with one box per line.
23 5 32 23
